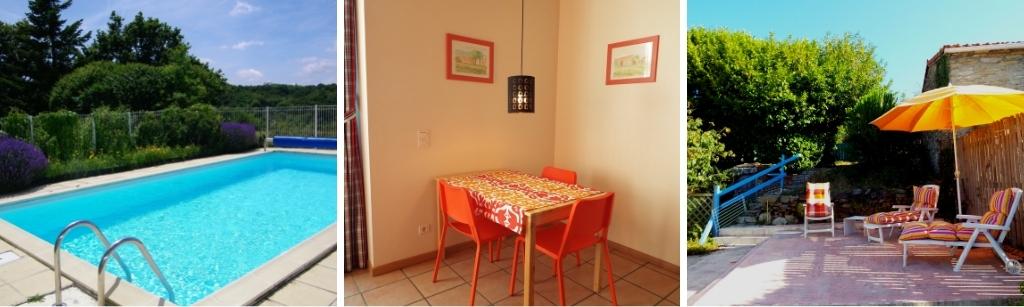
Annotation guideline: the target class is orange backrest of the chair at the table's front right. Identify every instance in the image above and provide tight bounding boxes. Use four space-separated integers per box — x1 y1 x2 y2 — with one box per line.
558 192 615 255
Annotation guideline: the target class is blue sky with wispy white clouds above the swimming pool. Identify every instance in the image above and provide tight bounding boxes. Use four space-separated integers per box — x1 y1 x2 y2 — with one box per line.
0 0 338 84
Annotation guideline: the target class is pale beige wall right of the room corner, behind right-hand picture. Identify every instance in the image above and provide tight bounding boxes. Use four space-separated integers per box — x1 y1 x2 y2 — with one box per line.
555 0 682 265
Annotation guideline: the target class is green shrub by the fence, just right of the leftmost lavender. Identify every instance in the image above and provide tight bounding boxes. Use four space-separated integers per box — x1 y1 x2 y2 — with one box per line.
35 111 82 161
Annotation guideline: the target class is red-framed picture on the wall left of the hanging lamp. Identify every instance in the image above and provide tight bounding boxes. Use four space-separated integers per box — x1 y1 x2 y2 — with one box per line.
445 33 495 83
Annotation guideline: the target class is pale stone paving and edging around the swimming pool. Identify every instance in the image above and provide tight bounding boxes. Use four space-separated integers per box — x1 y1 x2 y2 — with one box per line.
0 149 337 306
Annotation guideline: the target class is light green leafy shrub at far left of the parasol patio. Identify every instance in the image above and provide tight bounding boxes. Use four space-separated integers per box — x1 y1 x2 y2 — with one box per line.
686 109 733 193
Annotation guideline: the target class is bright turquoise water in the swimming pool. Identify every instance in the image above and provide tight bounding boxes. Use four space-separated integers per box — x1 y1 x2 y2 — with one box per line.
0 152 338 305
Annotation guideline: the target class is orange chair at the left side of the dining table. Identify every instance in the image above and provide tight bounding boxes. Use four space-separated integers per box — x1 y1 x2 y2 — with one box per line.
433 181 513 305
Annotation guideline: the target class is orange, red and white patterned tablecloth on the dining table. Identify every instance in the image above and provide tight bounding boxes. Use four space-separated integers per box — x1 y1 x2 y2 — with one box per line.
444 170 601 233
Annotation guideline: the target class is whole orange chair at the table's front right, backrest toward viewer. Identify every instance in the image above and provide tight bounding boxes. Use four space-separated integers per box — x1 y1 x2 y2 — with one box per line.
509 192 618 305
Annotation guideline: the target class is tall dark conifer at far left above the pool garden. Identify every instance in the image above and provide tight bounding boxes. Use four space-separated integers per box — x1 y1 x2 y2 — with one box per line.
23 0 89 114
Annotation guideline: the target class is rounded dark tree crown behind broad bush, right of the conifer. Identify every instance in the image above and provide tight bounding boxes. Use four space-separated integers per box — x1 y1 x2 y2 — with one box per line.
86 11 187 65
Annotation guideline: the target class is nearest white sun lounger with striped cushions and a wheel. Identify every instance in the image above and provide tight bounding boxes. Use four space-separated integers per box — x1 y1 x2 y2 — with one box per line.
899 187 1022 274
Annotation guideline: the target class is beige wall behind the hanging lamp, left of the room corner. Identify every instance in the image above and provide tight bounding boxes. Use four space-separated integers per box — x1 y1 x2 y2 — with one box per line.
359 0 558 265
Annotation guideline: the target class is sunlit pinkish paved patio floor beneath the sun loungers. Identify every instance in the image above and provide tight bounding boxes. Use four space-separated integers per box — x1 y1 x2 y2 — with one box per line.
693 232 1024 305
